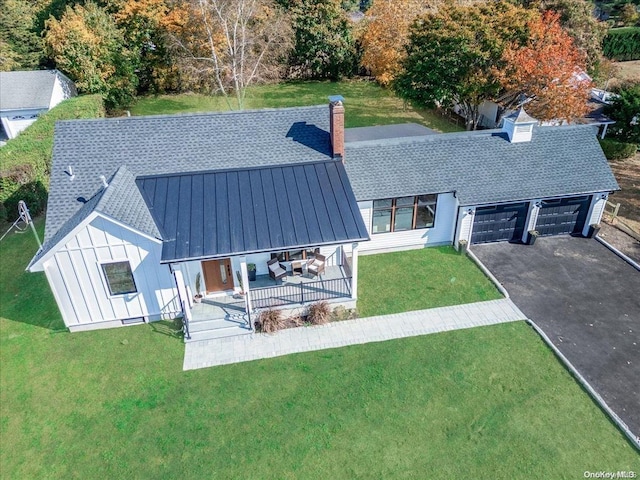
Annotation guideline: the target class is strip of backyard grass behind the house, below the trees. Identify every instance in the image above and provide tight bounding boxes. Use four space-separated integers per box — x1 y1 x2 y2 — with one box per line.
131 80 462 132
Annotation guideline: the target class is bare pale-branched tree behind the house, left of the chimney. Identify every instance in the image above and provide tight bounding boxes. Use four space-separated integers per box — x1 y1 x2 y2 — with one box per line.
169 0 291 109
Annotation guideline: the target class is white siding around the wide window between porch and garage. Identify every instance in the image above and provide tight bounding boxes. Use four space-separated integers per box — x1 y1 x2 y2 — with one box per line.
358 193 458 254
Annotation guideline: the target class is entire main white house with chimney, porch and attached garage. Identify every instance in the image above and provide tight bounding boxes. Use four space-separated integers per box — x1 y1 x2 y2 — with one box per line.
28 97 618 339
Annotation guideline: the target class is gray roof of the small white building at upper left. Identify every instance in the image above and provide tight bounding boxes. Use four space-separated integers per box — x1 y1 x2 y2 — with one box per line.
0 70 75 110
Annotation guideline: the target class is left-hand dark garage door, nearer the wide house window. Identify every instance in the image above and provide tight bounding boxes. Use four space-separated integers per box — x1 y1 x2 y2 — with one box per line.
471 203 528 243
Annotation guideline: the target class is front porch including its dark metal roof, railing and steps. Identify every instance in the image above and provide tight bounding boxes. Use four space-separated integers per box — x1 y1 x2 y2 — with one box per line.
136 159 369 340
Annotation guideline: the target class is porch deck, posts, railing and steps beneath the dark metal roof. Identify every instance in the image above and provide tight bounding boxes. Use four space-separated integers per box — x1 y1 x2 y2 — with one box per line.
172 244 358 341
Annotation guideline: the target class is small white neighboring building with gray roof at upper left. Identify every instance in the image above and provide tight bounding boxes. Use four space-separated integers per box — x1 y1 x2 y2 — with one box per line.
0 70 77 140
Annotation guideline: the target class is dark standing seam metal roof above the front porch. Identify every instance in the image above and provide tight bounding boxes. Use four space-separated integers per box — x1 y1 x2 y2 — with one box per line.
137 161 369 262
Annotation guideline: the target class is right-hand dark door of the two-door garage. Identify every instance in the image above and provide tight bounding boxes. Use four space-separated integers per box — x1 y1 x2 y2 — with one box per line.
536 196 591 236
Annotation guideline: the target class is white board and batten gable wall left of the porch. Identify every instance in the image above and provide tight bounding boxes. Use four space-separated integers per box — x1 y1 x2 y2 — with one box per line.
43 215 180 331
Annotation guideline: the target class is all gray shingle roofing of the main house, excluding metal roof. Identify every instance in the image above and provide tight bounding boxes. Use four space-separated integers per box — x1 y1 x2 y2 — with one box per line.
40 105 618 266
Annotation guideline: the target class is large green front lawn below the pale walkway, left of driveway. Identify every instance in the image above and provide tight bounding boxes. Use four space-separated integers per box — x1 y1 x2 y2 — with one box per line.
0 220 638 480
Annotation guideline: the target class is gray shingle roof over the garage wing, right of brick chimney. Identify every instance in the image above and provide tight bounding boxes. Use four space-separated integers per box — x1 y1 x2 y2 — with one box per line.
345 126 619 205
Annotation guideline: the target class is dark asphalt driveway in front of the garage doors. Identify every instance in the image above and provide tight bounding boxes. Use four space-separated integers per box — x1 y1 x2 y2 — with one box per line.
472 236 640 435
